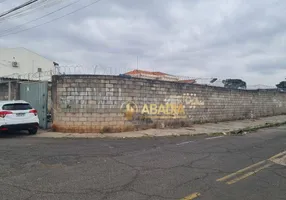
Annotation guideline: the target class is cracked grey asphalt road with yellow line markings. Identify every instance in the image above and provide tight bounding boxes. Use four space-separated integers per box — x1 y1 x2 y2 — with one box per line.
0 126 286 200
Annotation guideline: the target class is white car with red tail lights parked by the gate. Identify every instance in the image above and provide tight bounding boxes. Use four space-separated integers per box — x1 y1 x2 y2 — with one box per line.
0 101 39 134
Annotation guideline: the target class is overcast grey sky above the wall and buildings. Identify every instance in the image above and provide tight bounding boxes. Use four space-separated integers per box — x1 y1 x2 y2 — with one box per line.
0 0 286 85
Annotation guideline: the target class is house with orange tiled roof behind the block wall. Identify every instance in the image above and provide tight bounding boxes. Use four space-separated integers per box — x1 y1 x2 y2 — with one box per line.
125 69 196 84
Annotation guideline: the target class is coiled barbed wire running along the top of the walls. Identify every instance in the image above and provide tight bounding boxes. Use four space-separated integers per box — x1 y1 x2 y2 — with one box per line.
0 65 277 90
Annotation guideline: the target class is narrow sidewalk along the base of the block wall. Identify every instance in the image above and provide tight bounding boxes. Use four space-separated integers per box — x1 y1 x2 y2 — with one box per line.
34 115 286 138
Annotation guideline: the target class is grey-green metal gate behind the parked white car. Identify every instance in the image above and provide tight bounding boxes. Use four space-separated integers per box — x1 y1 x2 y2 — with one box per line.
20 82 48 129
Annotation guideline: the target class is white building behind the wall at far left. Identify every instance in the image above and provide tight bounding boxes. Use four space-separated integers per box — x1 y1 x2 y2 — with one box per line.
0 48 58 80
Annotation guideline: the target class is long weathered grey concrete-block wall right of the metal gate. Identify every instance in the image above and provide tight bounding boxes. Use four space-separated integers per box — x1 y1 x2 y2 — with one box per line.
52 75 286 132
